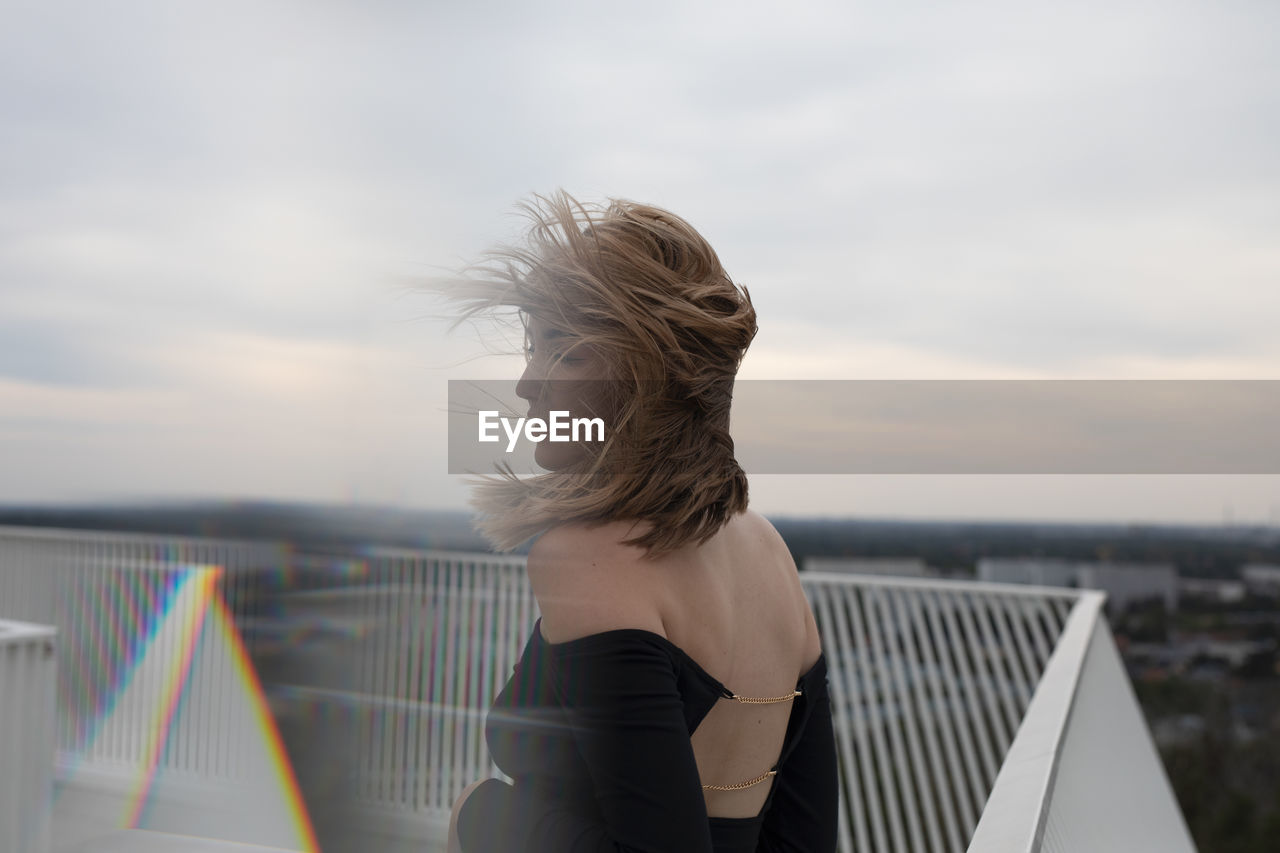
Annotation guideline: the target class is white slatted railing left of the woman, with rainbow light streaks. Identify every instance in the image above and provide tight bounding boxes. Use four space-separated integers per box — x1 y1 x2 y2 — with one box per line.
0 526 536 849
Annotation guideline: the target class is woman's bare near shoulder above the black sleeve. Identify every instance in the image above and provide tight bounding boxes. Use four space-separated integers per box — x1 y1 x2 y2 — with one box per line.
529 523 664 643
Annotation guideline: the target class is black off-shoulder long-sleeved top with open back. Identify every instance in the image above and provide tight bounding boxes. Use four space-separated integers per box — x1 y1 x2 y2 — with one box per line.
458 622 838 853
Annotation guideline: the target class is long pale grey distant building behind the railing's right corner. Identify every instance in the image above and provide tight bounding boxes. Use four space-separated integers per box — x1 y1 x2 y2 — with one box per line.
978 557 1178 612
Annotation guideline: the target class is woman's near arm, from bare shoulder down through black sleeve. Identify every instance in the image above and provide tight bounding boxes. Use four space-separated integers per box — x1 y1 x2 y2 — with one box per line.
460 528 712 853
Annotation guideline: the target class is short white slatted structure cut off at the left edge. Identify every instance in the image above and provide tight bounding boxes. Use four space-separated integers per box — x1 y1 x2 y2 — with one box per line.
0 621 58 853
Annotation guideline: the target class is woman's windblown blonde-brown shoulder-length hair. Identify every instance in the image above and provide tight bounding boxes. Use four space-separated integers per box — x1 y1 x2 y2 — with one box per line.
449 192 756 556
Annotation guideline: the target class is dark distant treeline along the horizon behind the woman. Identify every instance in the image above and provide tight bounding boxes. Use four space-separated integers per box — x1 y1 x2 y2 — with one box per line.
0 502 1280 578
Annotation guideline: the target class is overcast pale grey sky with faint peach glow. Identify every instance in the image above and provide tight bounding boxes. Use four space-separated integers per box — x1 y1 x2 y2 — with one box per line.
0 0 1280 521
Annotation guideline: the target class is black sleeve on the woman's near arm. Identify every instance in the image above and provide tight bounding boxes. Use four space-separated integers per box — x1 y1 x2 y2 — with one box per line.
458 634 712 853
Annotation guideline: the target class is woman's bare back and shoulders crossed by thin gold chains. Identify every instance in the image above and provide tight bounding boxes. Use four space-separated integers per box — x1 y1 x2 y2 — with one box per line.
530 512 820 817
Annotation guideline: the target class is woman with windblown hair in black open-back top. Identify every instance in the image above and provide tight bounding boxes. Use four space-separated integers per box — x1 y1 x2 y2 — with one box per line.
449 193 837 853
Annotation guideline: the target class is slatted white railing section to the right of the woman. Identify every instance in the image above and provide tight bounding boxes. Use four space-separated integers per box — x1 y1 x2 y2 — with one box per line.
801 573 1076 852
